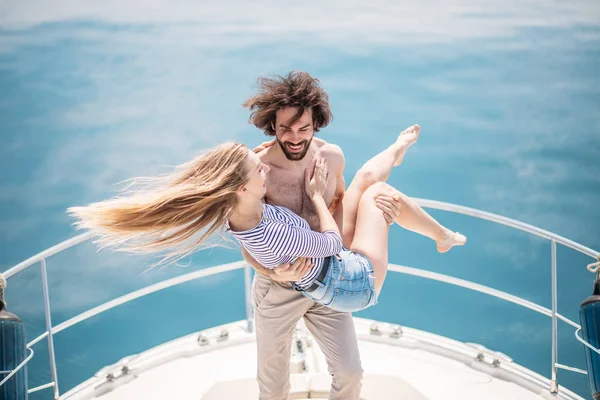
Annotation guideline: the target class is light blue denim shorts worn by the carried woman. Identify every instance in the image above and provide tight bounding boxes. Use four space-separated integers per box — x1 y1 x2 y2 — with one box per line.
302 249 377 312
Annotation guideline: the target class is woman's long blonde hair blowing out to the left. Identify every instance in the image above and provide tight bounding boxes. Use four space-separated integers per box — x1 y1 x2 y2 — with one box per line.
68 143 248 264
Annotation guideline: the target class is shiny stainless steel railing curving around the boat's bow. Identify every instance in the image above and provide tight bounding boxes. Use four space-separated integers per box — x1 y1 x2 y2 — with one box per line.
0 199 600 399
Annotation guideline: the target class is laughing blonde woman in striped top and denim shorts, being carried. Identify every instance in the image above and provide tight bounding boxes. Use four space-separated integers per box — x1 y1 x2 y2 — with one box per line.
69 139 466 312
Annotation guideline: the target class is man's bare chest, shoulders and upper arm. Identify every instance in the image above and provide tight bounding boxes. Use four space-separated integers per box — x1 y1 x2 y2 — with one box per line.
258 138 344 230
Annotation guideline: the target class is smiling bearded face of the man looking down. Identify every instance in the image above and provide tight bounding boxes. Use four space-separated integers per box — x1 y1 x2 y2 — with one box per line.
275 107 315 161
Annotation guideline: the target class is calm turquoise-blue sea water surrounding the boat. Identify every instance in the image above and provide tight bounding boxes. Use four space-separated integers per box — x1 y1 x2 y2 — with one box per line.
0 1 600 400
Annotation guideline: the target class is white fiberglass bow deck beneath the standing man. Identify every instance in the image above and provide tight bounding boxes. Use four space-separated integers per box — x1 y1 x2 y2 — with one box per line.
61 318 580 400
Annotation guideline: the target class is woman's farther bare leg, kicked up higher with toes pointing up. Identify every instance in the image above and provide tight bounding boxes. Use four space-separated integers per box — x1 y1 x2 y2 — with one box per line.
342 125 421 248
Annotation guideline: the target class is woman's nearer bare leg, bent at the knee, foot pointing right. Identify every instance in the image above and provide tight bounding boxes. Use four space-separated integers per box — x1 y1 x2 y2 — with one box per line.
350 182 467 292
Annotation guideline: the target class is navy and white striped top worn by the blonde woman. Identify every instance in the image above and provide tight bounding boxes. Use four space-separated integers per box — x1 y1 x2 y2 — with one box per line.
227 204 343 289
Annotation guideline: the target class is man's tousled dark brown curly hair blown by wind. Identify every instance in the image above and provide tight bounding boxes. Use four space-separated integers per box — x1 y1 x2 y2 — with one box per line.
243 71 333 136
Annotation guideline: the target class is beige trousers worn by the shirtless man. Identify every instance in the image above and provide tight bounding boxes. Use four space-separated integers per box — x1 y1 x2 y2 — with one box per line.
252 274 363 400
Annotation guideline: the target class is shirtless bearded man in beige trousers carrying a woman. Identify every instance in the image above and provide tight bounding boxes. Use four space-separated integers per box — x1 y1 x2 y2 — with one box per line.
242 72 398 400
